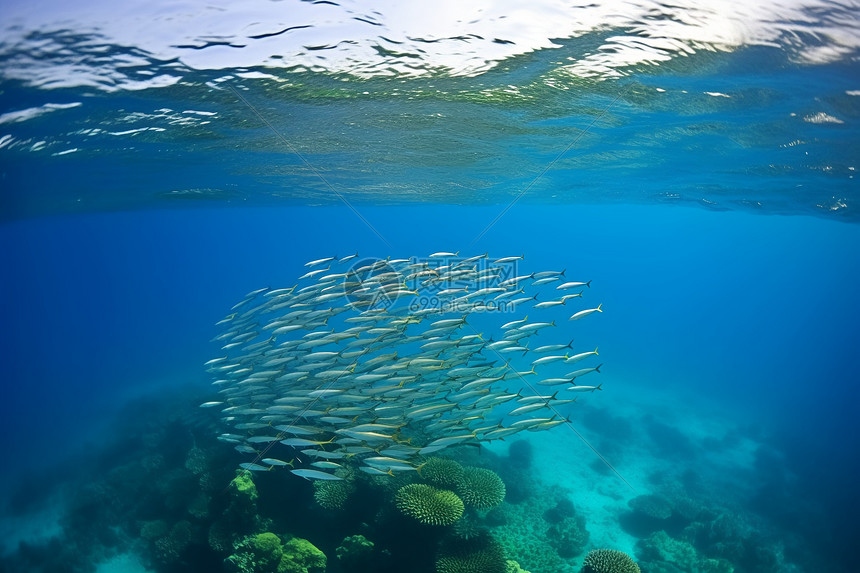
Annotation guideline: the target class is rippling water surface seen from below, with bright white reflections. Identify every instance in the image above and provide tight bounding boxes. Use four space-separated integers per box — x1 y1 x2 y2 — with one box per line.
0 1 860 220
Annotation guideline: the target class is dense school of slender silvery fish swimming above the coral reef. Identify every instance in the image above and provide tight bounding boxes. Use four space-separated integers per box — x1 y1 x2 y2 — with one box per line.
206 252 603 480
